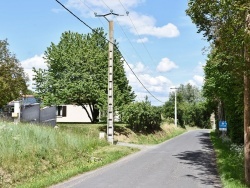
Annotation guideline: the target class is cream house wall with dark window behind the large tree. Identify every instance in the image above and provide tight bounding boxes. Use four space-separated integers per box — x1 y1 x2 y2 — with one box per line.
56 105 91 123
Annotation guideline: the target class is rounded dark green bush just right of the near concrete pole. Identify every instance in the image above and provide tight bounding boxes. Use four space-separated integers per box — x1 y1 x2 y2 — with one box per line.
123 98 162 132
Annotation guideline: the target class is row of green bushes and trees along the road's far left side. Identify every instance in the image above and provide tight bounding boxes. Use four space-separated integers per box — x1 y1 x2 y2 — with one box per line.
122 84 214 132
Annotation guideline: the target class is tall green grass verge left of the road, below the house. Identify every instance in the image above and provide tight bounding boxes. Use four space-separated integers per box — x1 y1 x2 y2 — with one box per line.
0 122 136 187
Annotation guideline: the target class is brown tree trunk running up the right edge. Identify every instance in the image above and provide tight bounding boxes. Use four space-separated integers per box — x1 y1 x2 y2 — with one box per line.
244 12 250 185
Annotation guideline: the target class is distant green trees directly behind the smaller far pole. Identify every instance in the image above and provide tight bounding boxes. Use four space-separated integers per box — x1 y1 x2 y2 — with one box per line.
163 84 212 128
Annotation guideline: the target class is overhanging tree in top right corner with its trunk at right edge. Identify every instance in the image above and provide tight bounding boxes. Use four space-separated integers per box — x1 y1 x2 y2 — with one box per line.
187 0 250 184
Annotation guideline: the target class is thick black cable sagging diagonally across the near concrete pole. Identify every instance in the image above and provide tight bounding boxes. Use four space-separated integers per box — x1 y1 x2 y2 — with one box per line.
55 0 164 103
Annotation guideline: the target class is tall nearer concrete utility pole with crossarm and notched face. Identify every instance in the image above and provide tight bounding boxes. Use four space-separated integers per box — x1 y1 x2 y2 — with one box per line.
95 10 122 144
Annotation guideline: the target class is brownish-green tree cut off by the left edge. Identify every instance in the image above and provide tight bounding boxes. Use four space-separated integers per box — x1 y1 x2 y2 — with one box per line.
0 40 28 108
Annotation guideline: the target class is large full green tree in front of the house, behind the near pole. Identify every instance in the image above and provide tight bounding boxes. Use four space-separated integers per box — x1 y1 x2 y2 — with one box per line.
34 29 135 123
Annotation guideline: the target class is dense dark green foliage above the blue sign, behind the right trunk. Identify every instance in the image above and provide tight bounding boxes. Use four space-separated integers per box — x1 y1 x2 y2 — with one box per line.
203 49 244 143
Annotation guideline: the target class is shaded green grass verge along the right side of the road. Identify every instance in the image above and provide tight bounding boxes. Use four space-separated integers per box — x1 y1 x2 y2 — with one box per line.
211 132 248 188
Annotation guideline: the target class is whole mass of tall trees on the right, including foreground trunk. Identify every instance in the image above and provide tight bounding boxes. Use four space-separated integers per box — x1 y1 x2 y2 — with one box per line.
187 0 250 185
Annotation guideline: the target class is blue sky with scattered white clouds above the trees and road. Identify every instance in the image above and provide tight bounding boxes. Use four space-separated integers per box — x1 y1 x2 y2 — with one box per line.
0 0 209 106
